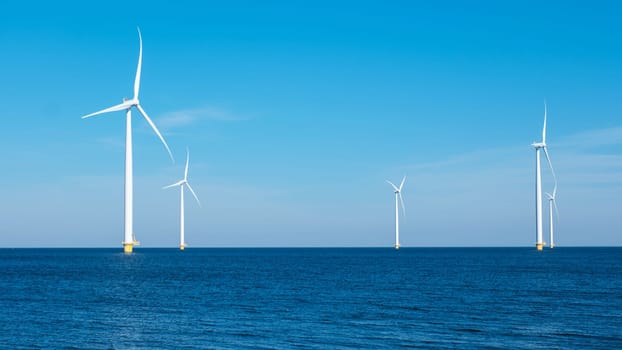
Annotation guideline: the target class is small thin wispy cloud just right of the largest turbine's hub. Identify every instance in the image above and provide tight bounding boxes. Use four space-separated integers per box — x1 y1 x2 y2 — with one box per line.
157 106 248 129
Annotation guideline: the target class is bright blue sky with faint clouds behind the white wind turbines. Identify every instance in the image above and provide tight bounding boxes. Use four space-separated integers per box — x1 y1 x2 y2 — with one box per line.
0 0 622 247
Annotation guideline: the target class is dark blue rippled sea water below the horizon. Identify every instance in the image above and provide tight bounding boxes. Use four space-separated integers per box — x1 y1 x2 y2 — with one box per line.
0 247 622 349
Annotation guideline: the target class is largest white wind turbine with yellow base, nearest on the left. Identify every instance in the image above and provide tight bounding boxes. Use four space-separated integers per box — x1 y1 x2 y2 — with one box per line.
82 28 174 253
